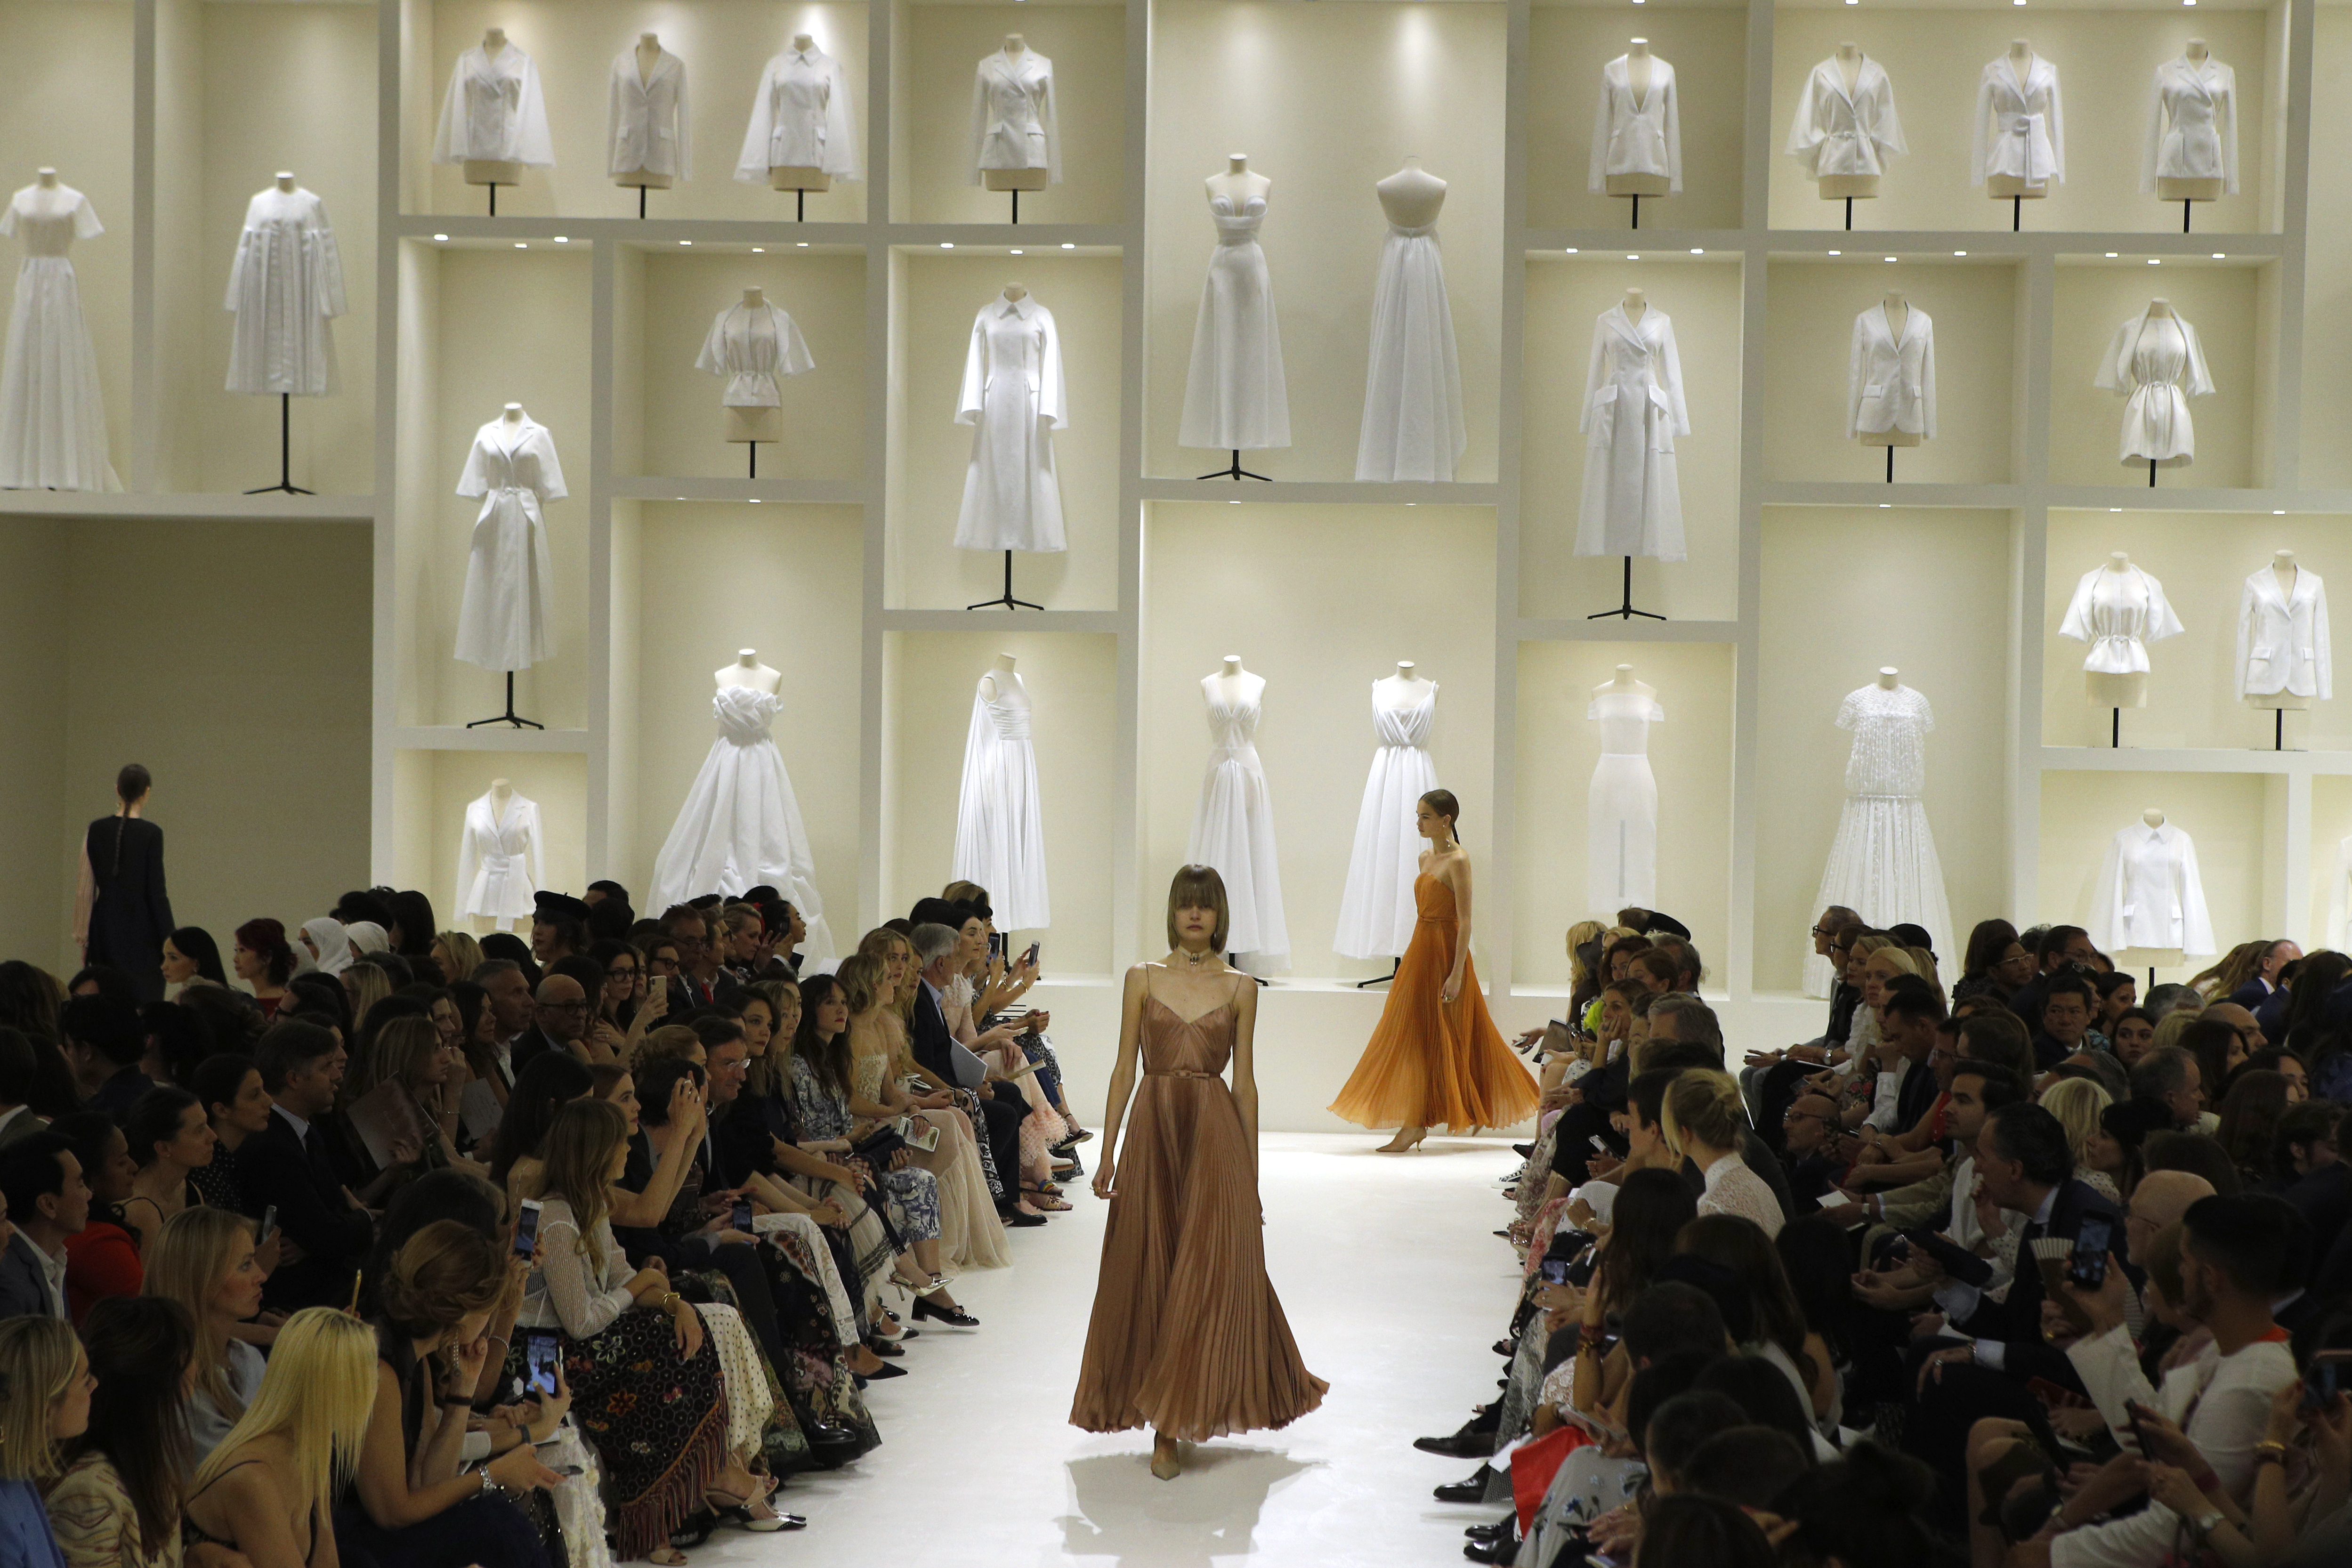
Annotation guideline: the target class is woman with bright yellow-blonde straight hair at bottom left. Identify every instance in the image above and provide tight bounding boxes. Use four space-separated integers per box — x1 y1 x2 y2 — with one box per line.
184 1307 376 1568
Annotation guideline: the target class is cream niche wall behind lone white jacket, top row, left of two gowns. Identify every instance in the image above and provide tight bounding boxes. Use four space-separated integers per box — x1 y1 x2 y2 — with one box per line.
898 2 1127 223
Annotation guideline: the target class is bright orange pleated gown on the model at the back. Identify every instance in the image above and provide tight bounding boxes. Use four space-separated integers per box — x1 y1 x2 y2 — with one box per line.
1331 872 1543 1131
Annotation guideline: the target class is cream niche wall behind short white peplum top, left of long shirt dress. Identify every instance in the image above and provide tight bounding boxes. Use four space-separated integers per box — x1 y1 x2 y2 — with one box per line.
623 247 875 479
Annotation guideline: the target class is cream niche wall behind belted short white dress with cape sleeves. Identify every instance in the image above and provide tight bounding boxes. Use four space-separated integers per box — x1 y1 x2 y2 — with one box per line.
2060 261 2270 489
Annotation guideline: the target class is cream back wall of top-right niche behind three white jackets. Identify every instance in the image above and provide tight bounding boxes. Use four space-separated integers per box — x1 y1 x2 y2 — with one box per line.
1771 7 2267 240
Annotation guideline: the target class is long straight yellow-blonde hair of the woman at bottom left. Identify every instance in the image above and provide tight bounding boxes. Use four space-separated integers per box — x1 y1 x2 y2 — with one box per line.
188 1307 376 1511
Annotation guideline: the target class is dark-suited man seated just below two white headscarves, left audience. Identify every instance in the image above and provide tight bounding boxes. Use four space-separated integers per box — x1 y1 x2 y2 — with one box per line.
237 1020 376 1312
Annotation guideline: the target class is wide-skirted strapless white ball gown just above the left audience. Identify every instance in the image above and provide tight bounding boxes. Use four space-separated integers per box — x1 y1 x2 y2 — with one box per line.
647 687 832 973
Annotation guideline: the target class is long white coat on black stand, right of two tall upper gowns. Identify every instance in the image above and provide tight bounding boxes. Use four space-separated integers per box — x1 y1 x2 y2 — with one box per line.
1576 303 1691 562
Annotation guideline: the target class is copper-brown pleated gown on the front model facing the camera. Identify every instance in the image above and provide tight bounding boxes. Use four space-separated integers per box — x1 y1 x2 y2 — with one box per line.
1070 978 1331 1441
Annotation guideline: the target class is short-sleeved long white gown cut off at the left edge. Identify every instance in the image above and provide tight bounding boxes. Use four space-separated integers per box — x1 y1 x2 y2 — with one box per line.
0 186 122 491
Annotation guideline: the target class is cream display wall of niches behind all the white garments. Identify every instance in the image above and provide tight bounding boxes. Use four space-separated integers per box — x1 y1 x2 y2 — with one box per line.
14 0 2352 1128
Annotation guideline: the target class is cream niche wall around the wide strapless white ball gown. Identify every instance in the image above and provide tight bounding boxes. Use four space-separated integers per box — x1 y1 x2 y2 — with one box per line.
609 501 865 936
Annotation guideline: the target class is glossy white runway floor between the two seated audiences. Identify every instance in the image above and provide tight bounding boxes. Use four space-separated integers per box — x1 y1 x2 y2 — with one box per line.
692 1133 1515 1568
